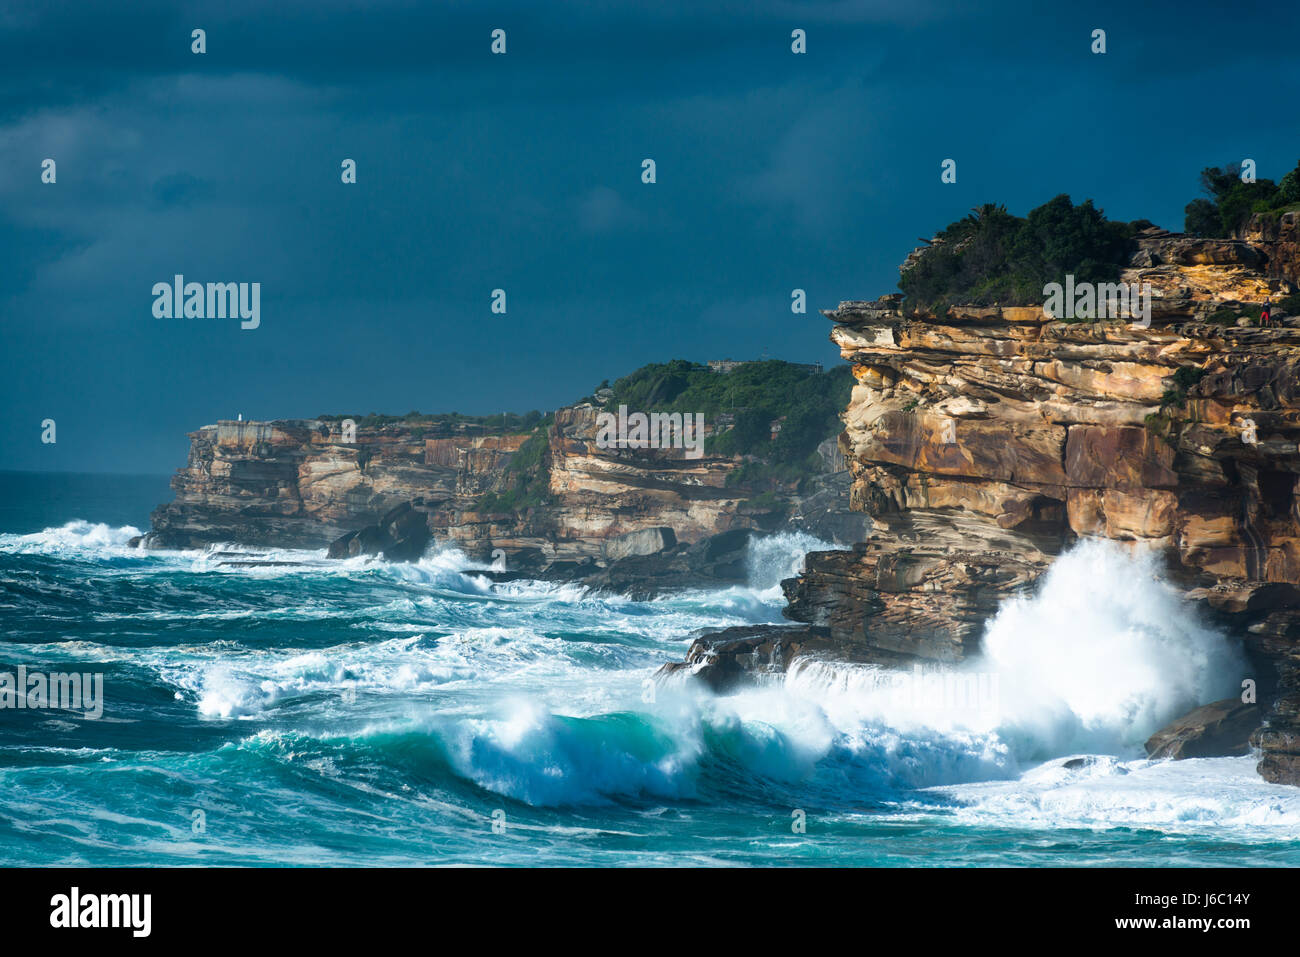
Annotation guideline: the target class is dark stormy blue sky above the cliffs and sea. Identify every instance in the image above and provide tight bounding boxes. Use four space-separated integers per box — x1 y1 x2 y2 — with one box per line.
0 0 1300 472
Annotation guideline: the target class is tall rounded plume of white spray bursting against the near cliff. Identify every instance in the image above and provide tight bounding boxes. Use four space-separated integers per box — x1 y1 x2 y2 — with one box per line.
972 540 1245 757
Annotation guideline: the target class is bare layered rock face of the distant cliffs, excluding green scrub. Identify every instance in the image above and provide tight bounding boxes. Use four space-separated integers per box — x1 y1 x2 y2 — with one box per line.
147 404 863 572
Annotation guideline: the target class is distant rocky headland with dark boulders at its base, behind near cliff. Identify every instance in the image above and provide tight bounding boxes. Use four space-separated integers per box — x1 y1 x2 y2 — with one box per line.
143 364 866 597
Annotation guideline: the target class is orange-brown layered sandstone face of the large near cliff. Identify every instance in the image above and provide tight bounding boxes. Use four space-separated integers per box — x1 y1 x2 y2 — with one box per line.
785 226 1300 783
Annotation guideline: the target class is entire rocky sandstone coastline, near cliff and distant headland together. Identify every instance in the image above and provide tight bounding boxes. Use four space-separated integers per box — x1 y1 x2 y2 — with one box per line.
144 201 1300 784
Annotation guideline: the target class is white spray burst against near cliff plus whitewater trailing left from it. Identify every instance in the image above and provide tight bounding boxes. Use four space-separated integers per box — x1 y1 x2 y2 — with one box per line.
785 541 1244 767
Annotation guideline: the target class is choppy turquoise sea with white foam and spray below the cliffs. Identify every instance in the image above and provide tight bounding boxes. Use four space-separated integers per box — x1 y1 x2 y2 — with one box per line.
0 473 1300 866
